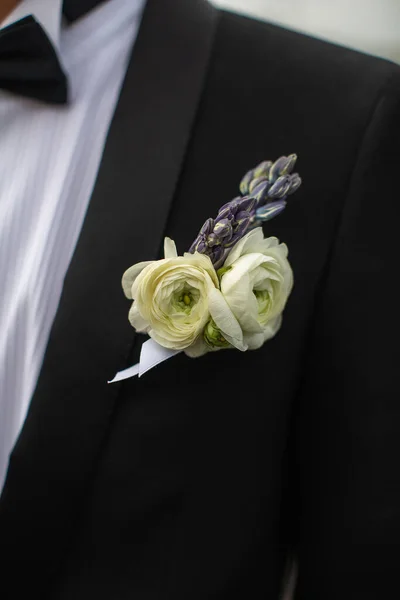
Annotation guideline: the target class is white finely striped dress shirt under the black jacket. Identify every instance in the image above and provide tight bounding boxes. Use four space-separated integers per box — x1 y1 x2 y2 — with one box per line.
0 0 144 491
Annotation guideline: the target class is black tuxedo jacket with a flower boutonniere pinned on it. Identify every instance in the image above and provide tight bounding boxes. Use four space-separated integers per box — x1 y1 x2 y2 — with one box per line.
0 0 400 600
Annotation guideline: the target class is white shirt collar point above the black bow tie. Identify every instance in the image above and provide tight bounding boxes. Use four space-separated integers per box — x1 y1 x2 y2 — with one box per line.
0 0 62 50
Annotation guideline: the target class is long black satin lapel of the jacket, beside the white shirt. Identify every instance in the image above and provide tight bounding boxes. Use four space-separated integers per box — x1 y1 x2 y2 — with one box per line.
0 0 216 584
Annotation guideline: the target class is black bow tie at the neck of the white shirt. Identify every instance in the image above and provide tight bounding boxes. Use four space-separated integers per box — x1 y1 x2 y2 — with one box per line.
0 0 103 104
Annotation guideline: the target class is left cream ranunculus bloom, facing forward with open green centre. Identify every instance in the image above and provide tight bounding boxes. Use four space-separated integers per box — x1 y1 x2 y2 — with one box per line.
122 238 246 356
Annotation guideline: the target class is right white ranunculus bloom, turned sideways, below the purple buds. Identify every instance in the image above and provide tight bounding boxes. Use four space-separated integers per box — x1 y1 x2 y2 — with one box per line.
220 227 293 350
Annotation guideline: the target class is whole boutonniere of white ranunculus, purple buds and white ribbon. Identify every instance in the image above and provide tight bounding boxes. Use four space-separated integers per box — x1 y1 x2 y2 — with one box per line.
110 154 301 383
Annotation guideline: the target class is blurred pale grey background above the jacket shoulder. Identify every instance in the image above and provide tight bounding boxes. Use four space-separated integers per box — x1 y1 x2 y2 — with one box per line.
212 0 400 63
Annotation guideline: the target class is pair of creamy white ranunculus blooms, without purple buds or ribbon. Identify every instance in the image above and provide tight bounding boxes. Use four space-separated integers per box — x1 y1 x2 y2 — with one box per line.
122 227 293 357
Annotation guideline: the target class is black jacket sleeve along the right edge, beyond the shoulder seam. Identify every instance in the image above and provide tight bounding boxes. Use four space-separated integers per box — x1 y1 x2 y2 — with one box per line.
292 69 400 600
